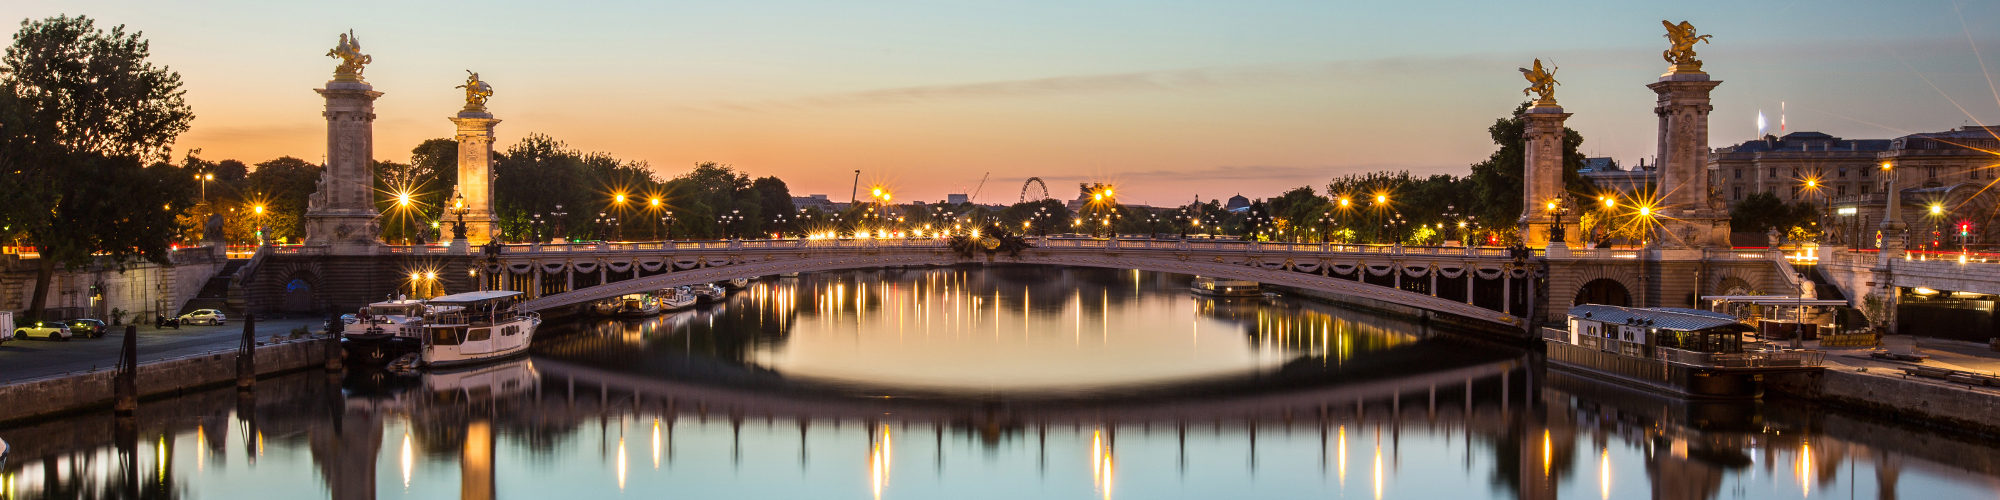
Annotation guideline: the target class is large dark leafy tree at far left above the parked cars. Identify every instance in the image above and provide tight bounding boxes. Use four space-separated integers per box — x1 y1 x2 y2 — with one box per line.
0 16 196 316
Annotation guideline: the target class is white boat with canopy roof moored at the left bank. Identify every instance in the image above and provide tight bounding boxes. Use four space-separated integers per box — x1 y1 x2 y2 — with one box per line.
422 290 542 368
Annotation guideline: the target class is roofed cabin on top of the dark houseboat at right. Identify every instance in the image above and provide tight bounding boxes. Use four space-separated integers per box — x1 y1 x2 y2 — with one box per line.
1568 304 1752 356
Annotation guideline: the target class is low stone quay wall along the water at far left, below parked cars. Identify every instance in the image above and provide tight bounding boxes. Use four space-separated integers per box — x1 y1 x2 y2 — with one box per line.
0 338 340 422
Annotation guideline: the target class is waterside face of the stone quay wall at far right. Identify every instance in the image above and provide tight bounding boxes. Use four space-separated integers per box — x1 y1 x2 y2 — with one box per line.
1766 368 2000 436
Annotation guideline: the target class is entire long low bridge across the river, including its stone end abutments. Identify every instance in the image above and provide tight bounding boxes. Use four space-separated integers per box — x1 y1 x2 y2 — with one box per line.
240 238 1802 332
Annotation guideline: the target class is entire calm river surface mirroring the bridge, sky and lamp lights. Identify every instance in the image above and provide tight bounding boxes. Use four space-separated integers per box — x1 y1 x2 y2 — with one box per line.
0 268 2000 498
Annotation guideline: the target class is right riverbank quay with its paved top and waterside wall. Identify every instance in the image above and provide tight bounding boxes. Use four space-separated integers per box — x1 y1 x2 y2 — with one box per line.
1766 338 2000 438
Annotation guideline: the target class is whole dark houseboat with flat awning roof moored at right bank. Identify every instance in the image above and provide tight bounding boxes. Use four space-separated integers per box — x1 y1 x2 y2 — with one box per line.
1544 304 1824 398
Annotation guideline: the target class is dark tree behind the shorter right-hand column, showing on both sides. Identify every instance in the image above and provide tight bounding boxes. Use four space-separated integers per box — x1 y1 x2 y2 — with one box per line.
1470 102 1596 242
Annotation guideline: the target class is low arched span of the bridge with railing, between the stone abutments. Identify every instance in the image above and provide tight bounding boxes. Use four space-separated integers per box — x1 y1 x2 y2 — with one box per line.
482 238 1542 328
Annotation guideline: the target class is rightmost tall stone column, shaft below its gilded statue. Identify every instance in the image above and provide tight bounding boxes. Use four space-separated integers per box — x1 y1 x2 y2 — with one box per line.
1646 72 1730 248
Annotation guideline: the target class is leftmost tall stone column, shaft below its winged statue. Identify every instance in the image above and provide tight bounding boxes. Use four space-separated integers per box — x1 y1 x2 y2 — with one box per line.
306 80 382 254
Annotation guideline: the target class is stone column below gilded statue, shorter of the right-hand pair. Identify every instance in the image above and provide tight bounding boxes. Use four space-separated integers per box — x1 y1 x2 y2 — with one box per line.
1516 102 1578 248
